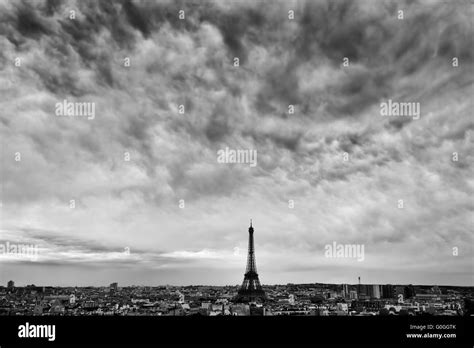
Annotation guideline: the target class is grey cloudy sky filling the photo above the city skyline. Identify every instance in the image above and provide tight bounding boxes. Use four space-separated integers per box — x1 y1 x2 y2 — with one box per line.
0 0 474 285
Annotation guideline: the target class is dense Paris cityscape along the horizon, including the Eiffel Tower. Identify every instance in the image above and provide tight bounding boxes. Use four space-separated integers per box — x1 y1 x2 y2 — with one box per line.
0 220 474 316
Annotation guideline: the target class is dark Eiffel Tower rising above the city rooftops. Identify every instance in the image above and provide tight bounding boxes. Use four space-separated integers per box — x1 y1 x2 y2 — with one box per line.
235 220 266 302
